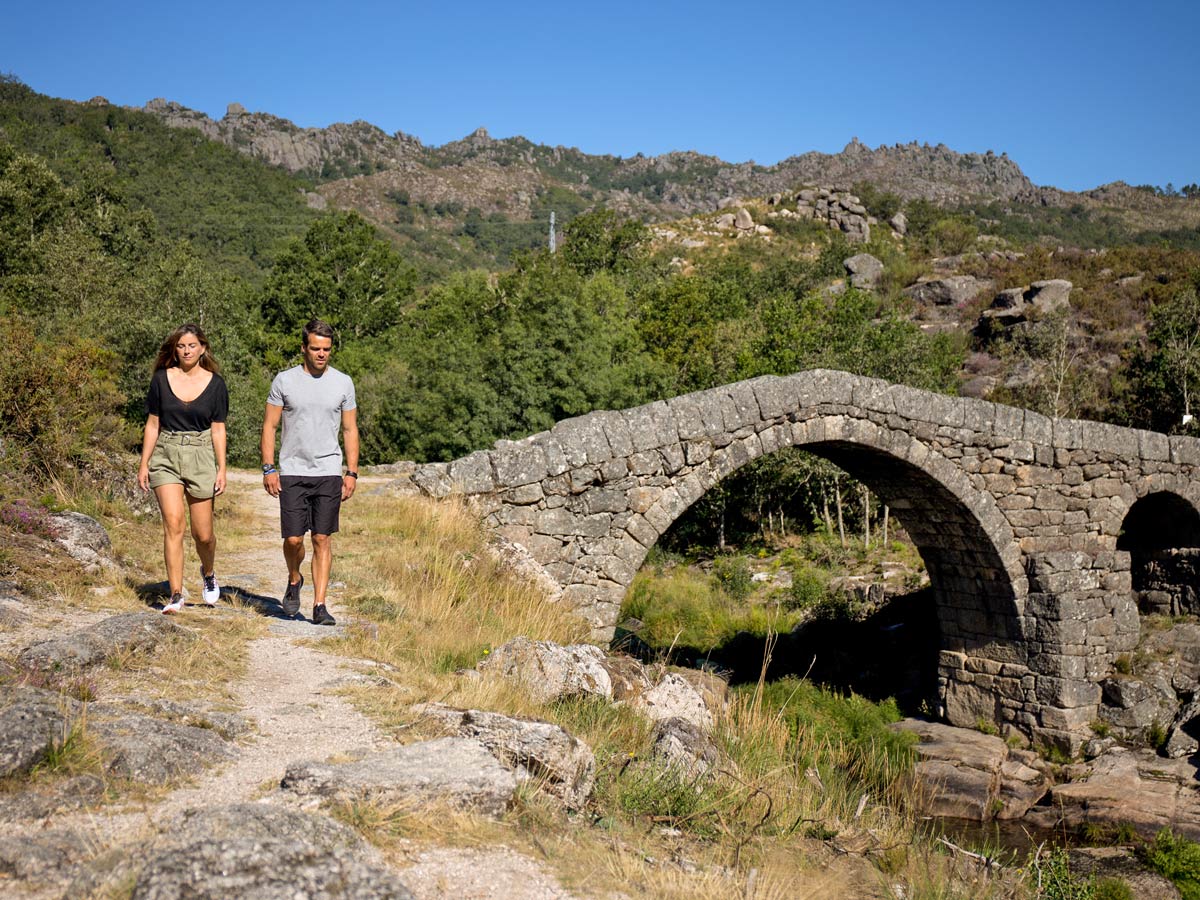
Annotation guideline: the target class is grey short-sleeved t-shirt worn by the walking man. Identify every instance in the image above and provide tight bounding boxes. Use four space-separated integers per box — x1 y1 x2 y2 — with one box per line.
266 366 356 475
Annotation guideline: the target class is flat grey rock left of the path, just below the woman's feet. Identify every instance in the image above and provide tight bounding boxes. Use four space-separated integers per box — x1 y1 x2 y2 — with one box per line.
17 611 190 672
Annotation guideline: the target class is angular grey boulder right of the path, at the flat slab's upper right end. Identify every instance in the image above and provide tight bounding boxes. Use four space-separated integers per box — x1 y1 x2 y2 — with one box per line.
418 703 596 809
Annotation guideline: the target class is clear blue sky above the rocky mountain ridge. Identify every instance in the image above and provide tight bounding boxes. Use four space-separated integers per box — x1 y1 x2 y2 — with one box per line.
0 0 1200 190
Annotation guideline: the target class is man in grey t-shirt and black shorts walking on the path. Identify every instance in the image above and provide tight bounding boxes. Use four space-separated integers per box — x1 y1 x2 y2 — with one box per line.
262 319 359 625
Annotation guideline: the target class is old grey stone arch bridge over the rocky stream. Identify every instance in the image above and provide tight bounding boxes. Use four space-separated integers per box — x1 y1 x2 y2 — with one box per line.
413 370 1200 750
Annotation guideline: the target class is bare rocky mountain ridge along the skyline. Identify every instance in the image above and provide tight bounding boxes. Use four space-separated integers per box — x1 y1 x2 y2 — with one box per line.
144 100 1037 218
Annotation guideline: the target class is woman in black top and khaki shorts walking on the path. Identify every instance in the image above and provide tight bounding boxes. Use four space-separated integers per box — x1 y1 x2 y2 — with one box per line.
138 324 229 613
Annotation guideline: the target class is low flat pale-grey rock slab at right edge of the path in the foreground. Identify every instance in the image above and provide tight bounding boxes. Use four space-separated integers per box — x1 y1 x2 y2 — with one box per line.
288 738 517 815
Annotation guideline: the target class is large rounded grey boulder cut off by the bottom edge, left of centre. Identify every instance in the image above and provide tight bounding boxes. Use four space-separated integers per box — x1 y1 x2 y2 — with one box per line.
82 803 413 900
